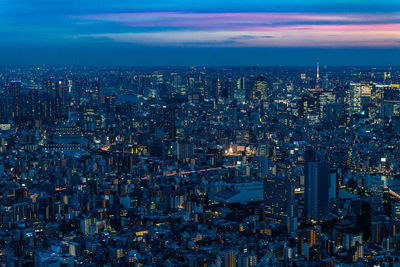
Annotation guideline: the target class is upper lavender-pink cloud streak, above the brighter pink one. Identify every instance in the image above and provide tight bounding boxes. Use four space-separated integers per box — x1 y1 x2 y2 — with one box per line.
81 12 400 29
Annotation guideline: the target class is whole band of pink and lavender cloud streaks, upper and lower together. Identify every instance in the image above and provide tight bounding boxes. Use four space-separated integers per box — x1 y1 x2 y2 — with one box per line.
77 12 400 47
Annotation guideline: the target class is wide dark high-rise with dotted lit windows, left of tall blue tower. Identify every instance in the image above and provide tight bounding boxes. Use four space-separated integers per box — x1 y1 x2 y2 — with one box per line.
264 174 297 232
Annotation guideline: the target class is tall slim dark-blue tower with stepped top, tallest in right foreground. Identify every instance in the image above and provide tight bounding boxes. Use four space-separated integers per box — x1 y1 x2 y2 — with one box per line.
304 148 329 220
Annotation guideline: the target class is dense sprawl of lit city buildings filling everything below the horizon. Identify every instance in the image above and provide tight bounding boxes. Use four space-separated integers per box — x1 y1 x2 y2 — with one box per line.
0 66 400 267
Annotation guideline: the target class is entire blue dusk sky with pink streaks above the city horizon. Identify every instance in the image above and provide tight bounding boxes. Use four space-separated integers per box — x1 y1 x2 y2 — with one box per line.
0 0 400 65
